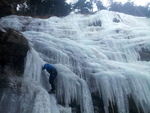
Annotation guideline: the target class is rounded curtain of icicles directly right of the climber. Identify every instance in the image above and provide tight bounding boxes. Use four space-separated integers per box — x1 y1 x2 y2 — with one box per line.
55 65 94 113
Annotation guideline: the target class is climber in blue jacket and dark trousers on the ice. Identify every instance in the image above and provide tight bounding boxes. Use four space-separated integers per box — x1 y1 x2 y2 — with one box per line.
42 64 58 93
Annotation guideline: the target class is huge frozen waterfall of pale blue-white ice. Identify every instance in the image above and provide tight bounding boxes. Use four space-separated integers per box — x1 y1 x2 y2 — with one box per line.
0 10 150 113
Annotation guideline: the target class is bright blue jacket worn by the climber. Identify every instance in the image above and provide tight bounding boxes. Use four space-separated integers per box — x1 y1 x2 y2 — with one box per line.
42 64 57 76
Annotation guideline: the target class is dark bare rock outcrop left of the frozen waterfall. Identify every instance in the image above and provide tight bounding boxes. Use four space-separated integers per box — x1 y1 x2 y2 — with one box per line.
0 29 29 75
